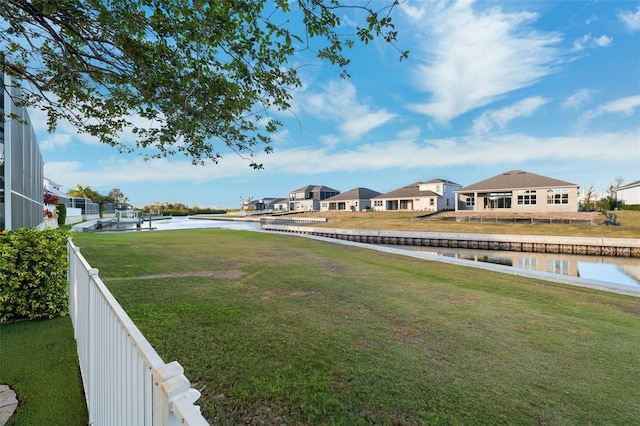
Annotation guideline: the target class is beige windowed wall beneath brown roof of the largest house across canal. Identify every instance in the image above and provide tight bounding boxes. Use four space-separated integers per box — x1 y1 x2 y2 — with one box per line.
456 186 578 213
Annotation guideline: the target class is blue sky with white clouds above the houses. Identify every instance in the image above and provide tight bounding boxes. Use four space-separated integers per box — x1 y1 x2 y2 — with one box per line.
38 1 640 208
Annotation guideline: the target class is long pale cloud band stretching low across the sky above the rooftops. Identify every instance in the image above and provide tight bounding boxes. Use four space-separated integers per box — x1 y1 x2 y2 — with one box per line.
45 125 640 198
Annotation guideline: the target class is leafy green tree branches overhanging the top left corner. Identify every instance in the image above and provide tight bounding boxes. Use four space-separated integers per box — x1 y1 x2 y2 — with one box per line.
0 0 407 168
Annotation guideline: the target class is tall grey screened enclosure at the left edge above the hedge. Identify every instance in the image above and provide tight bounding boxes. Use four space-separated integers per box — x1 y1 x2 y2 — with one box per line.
0 72 44 230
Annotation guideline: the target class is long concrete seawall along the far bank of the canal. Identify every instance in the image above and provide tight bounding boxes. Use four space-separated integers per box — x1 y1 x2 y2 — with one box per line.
262 223 640 258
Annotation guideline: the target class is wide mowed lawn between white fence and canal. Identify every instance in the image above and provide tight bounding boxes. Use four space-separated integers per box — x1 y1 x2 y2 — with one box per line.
73 229 640 425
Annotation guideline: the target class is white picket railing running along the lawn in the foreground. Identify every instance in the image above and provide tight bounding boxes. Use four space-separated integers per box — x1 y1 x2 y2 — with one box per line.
68 240 207 426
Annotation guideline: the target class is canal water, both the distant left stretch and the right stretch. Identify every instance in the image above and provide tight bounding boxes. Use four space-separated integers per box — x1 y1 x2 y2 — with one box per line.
152 217 640 289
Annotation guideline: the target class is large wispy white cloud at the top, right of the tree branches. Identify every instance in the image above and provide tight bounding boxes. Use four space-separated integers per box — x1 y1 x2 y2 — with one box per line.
409 2 561 123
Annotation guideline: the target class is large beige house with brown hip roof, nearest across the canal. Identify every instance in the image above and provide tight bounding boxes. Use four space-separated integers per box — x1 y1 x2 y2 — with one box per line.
454 170 579 213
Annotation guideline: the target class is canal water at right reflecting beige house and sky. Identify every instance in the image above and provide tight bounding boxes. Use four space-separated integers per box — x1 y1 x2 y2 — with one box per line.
394 246 640 287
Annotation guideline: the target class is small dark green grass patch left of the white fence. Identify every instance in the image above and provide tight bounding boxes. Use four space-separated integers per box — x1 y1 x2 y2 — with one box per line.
0 317 88 426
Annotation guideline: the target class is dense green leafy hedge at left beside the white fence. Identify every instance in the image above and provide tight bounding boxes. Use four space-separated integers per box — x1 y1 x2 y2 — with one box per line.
0 228 69 323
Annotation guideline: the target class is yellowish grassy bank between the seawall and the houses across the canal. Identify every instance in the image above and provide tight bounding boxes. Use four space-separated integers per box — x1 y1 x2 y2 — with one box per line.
295 211 640 238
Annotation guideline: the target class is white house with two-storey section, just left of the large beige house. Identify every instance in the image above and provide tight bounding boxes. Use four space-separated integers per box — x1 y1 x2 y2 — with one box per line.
371 179 462 211
